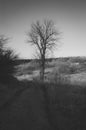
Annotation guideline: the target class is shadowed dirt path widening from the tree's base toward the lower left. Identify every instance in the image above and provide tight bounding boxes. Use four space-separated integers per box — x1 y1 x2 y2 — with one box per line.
0 87 51 130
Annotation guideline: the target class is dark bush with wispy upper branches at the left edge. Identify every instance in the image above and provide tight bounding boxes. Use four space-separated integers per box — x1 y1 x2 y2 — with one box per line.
0 36 18 83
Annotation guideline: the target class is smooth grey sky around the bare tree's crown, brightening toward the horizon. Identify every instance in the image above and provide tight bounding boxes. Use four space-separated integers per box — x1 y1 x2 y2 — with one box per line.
0 0 86 58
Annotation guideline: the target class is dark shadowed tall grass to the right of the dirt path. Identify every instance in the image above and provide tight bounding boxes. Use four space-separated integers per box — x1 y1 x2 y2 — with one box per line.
40 83 86 130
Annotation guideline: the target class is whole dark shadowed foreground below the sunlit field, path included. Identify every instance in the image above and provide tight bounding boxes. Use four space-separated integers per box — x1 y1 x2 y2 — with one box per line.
0 79 86 130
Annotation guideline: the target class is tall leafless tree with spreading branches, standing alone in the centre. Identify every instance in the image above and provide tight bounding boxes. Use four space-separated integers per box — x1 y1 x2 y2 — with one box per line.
28 20 60 81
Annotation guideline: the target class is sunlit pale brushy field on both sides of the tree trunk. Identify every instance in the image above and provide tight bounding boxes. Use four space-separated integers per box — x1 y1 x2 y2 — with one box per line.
16 57 86 84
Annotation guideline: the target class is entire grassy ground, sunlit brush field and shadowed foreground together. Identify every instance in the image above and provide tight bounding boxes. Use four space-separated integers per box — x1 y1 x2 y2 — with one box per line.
0 59 86 130
